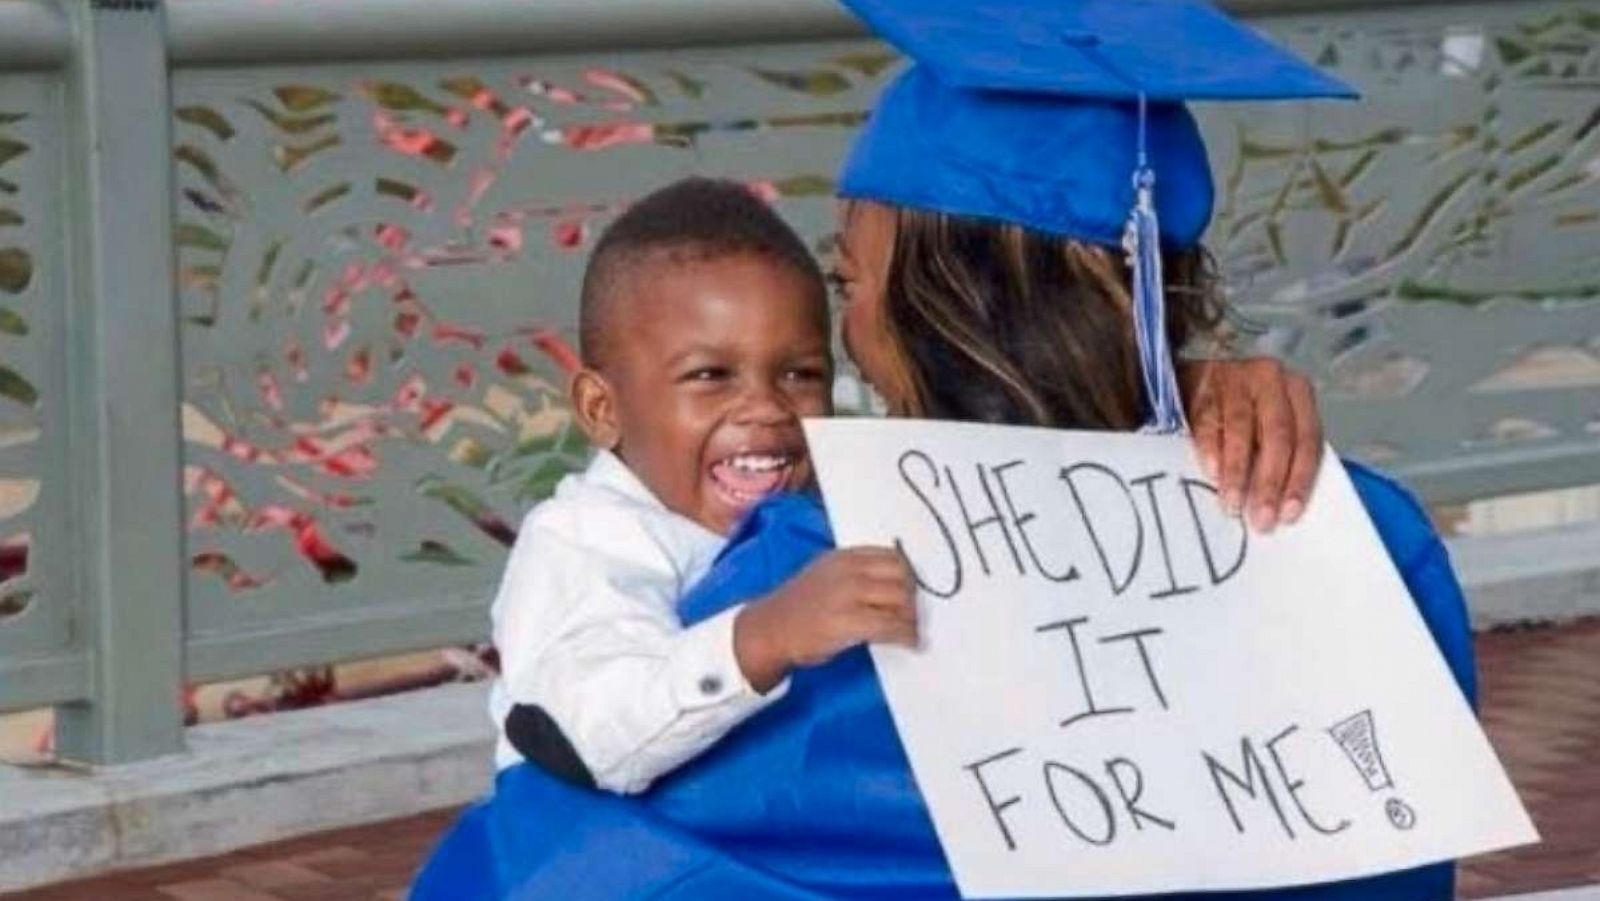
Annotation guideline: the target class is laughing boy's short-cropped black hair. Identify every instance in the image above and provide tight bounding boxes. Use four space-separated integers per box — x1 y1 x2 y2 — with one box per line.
578 178 827 366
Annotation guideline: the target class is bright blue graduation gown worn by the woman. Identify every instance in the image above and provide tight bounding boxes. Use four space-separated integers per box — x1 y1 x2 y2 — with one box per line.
411 464 1475 901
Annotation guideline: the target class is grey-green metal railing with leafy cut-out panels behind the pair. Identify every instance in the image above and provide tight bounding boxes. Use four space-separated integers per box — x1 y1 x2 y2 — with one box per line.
0 0 1600 762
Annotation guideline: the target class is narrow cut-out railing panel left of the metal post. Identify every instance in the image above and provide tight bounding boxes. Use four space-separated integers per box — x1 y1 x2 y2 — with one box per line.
0 75 74 672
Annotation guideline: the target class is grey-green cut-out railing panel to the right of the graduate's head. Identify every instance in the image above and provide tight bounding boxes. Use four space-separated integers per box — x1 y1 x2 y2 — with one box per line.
1205 3 1600 480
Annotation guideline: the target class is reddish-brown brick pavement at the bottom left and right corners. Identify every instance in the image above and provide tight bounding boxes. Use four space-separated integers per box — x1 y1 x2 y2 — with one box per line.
12 619 1600 901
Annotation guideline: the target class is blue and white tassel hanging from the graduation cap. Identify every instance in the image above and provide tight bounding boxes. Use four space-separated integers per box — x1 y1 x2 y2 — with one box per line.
1123 94 1189 434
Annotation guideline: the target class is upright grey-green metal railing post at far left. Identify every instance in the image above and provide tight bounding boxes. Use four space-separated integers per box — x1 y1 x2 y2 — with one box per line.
56 0 184 763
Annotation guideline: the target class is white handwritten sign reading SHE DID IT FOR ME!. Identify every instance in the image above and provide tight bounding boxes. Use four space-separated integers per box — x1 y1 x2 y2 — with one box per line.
806 419 1538 898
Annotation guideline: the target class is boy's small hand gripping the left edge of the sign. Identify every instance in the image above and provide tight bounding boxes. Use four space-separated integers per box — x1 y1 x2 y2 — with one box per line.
733 547 917 693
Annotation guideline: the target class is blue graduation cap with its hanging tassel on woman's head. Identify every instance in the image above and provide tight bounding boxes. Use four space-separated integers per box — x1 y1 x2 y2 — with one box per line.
840 0 1355 432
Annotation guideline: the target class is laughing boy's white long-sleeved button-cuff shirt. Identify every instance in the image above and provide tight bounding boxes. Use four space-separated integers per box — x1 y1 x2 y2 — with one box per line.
490 451 787 794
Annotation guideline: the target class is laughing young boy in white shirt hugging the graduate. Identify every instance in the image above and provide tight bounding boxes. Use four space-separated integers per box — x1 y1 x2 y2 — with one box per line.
490 179 915 792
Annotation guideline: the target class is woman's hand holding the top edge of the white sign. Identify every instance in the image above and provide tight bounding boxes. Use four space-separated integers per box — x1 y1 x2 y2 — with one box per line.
1178 357 1323 531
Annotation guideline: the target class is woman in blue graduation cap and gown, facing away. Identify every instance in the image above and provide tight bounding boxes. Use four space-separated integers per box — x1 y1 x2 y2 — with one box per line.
414 0 1474 901
